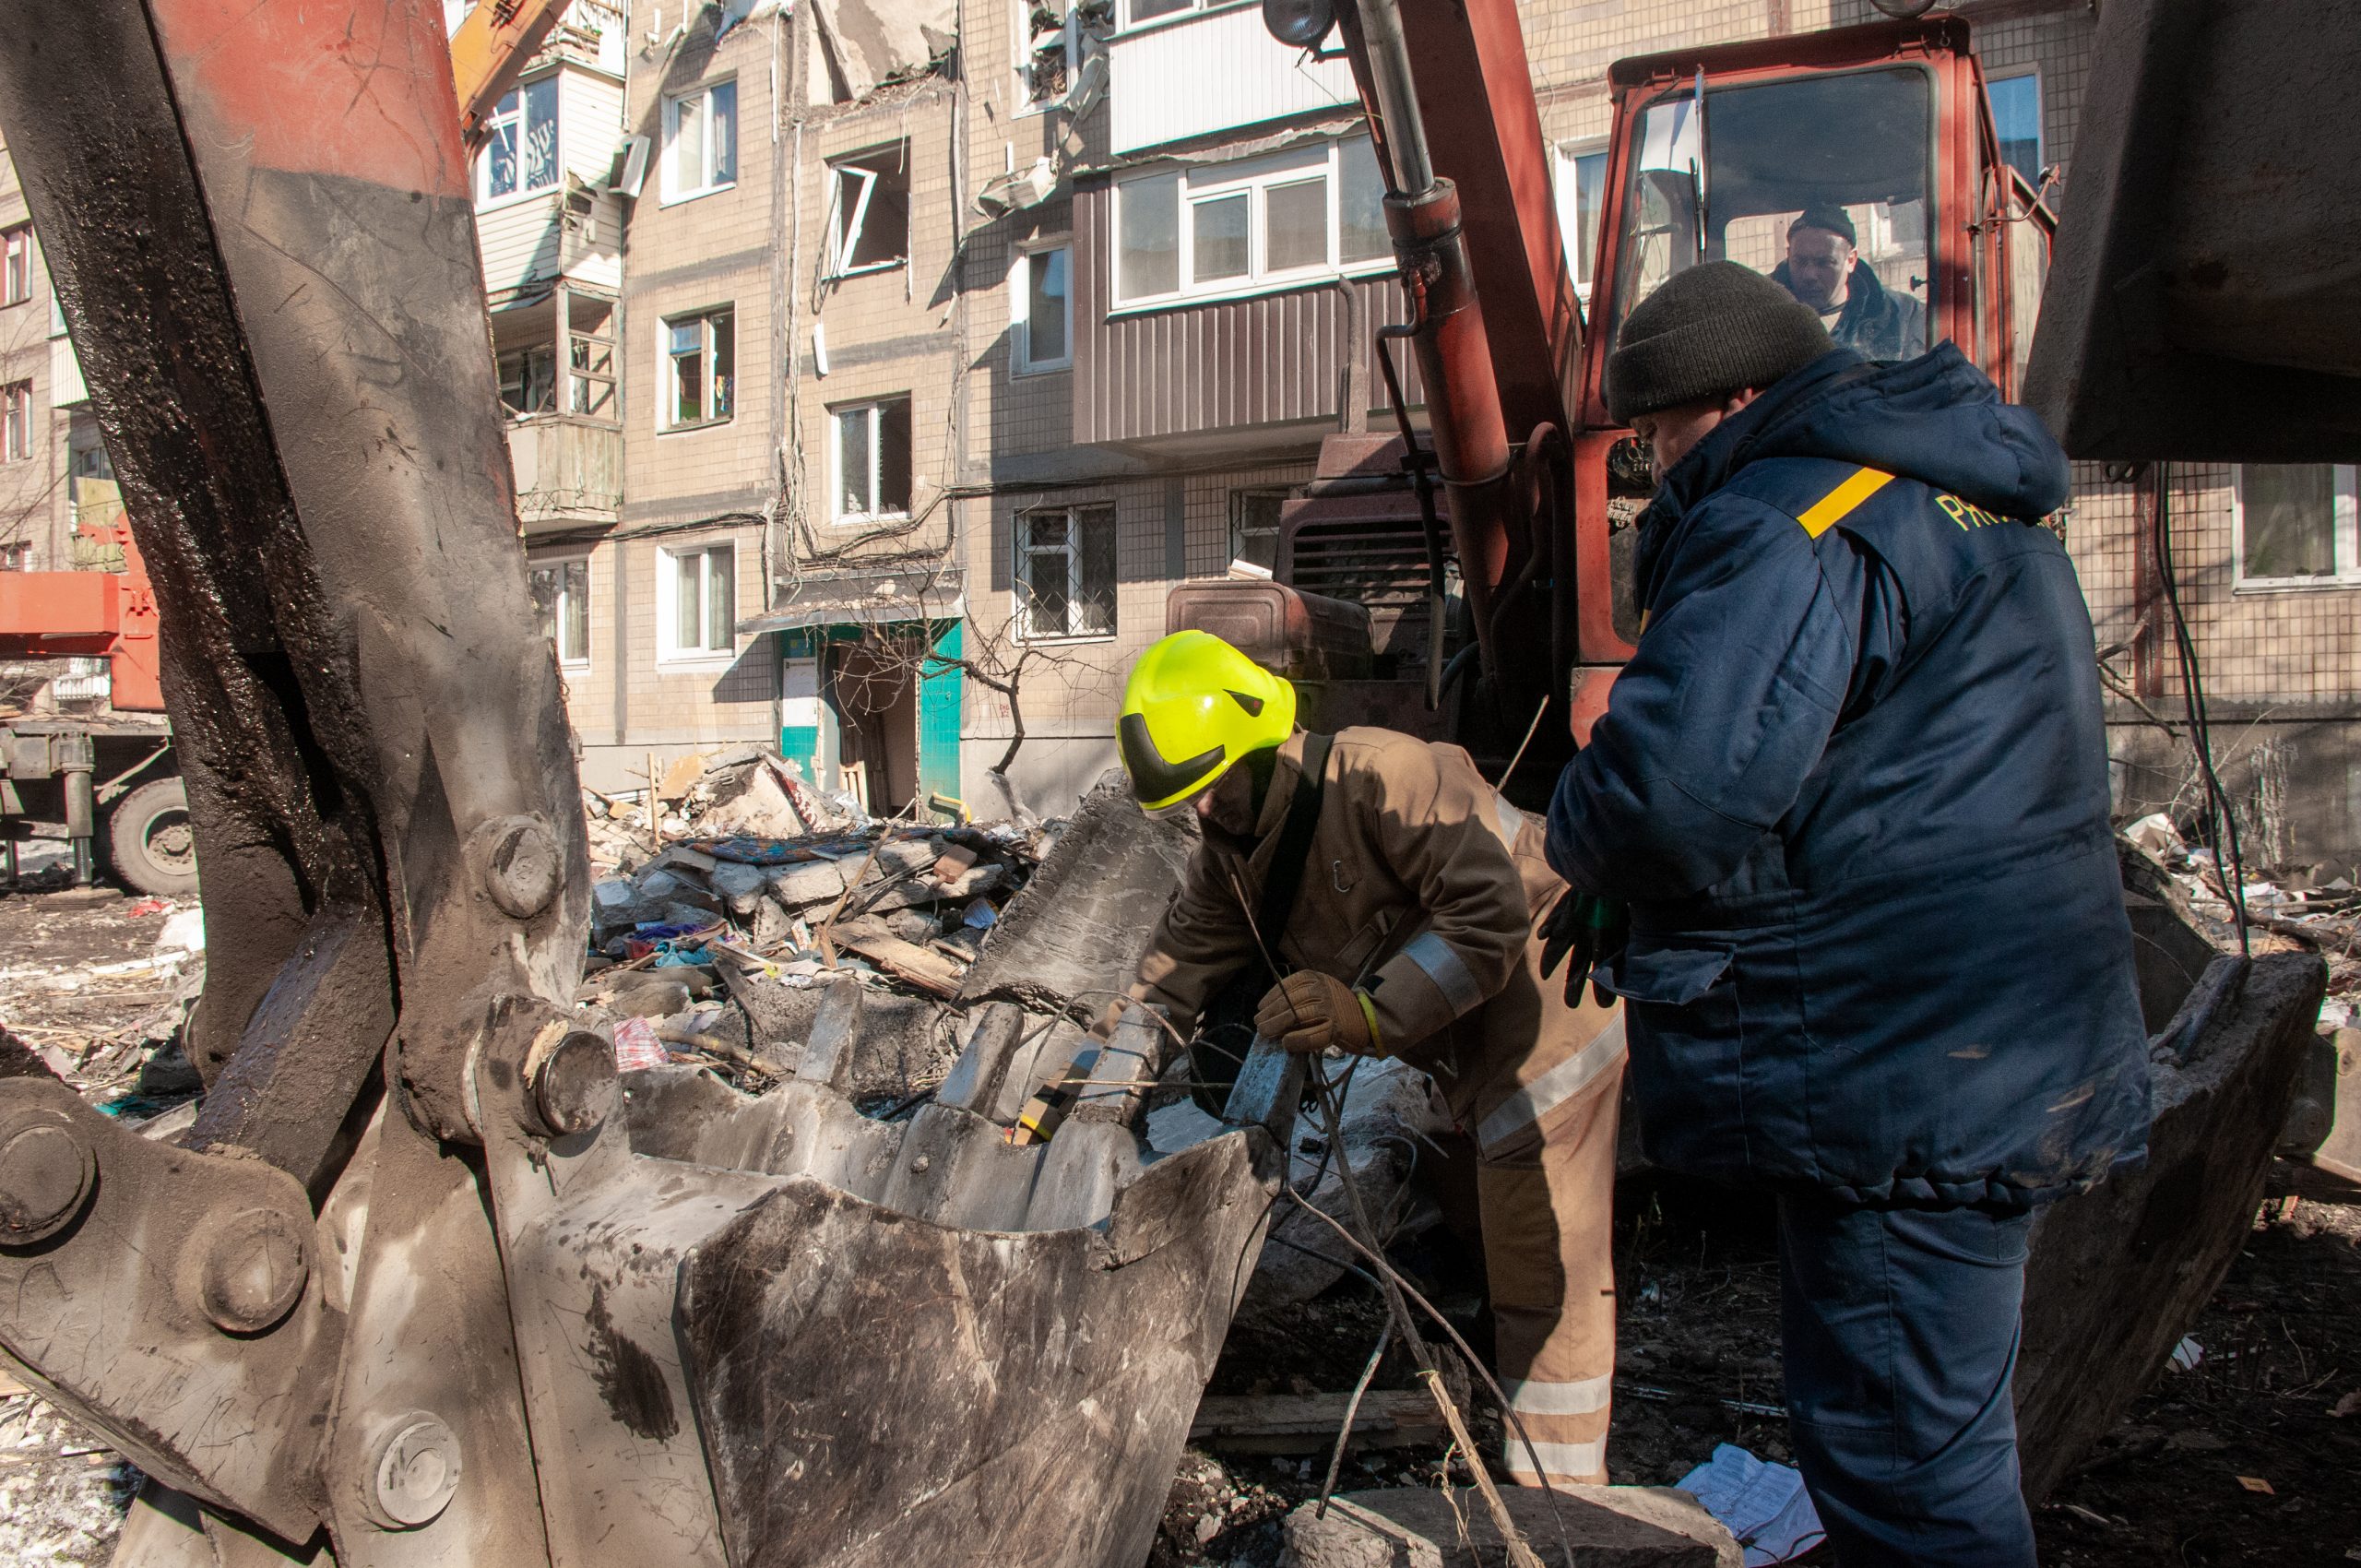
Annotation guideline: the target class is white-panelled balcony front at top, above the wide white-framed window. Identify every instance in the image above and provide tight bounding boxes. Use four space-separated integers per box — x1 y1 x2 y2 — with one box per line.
1108 5 1360 153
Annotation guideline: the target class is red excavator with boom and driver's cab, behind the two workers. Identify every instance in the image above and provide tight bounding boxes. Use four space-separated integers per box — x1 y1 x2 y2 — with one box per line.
1167 0 2054 765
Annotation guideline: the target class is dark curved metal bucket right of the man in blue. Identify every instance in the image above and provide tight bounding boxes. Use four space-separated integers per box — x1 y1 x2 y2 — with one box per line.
2016 954 2328 1502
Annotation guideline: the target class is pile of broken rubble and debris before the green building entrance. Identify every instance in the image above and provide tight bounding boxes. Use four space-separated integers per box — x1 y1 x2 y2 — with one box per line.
576 746 1050 1099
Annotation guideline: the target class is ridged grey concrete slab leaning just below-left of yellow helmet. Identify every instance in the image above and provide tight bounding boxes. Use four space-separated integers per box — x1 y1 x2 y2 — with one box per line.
958 770 1197 1008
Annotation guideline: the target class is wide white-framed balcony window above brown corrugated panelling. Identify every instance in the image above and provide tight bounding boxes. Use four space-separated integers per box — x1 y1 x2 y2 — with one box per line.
1108 135 1395 319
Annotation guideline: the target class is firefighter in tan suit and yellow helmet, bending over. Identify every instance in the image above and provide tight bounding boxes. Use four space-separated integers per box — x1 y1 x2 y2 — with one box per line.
1117 631 1624 1485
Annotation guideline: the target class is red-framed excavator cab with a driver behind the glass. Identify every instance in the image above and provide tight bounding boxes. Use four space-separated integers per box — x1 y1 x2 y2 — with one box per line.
1568 17 2052 694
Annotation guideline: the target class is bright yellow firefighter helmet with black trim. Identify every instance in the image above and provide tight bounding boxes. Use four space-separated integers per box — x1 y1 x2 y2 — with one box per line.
1114 631 1296 813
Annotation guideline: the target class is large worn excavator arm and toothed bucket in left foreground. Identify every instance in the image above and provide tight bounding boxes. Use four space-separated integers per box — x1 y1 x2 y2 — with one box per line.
0 0 1296 1568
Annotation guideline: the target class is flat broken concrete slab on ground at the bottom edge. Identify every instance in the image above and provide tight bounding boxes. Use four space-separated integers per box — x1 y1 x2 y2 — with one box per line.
1280 1485 1745 1568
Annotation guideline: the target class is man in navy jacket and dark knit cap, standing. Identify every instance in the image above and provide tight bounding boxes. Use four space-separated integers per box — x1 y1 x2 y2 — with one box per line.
1548 262 2149 1568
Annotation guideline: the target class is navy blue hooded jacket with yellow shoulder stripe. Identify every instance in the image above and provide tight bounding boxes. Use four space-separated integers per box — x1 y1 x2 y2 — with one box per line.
1548 345 2149 1206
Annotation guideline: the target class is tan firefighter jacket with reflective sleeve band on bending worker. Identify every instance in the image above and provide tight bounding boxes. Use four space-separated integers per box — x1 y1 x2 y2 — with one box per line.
1133 728 1622 1155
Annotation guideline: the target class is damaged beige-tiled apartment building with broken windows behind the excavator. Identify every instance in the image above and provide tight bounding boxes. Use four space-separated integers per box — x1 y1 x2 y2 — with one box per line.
456 0 2361 861
